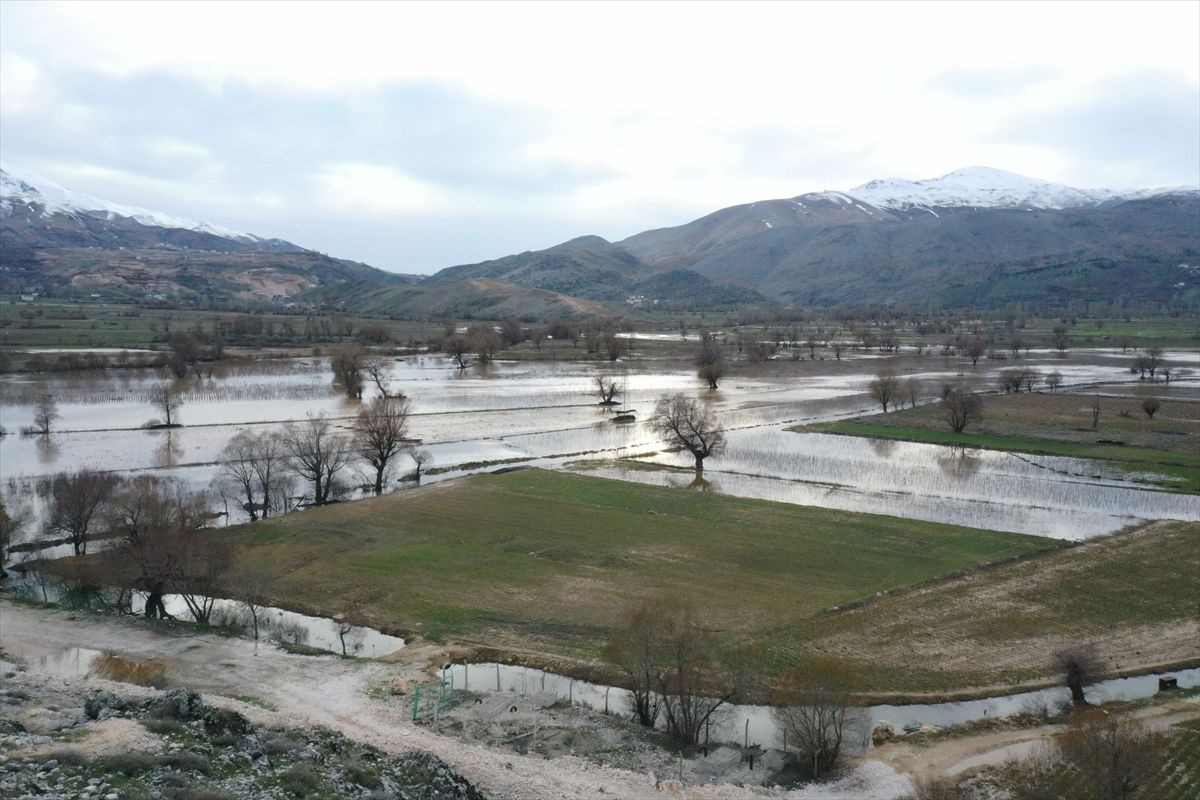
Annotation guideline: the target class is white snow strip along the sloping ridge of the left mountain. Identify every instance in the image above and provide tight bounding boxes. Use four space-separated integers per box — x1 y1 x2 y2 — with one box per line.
0 161 262 241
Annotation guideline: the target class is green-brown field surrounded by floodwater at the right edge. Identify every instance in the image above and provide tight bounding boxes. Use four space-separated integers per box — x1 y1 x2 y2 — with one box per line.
803 393 1200 494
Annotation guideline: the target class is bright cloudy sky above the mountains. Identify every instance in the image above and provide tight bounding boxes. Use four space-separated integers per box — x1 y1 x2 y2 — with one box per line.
0 0 1200 272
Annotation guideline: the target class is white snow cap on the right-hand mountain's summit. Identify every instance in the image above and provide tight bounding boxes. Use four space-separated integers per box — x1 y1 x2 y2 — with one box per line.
847 167 1172 210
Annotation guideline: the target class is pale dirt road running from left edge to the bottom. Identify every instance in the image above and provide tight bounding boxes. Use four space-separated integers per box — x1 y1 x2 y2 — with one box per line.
0 601 910 800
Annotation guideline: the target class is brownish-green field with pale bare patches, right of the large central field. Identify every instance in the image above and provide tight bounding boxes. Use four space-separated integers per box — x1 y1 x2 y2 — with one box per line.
774 522 1200 690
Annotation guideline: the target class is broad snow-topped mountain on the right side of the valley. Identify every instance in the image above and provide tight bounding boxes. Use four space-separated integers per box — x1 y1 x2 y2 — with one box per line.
618 168 1200 307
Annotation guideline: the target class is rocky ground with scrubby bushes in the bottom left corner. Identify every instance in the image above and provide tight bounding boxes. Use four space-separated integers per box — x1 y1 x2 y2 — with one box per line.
0 662 485 800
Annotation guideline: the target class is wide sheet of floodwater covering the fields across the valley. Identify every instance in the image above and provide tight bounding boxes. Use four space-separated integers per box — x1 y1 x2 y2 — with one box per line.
0 353 1200 556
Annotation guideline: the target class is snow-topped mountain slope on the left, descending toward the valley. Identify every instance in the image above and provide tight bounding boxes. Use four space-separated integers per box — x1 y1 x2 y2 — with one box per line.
0 163 414 303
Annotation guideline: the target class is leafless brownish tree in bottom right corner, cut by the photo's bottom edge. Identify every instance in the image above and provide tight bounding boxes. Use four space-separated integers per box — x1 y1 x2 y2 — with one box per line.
1058 710 1166 800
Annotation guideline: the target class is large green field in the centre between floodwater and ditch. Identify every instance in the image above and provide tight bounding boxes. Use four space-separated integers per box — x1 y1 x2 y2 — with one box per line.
216 470 1058 686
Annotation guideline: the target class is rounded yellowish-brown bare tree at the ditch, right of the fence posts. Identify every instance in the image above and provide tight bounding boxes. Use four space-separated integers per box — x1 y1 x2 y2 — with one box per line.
774 657 868 778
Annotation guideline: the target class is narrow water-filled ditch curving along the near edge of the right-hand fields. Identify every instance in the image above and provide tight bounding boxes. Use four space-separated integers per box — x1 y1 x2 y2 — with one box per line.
444 663 1200 748
